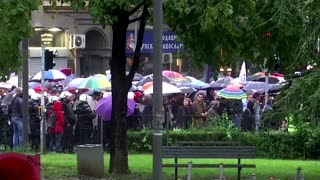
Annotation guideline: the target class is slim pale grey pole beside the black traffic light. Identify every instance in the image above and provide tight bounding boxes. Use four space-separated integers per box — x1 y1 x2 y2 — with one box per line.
40 46 46 154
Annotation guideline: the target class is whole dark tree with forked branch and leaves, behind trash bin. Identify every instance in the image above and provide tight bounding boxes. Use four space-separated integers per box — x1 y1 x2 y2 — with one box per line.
51 0 151 174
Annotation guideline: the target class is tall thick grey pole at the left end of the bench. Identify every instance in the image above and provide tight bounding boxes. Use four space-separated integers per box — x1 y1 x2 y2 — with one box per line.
152 0 164 180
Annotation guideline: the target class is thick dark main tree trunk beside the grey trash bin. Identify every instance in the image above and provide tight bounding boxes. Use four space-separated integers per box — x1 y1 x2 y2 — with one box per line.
109 12 130 174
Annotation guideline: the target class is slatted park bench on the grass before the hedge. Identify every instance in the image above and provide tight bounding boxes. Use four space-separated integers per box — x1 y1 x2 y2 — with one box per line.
162 141 256 179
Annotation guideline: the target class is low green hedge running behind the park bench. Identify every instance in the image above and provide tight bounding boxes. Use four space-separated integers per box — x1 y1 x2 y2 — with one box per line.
128 126 320 159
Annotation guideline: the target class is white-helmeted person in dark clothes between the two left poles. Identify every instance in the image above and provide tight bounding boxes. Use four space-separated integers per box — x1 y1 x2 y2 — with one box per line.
29 93 41 151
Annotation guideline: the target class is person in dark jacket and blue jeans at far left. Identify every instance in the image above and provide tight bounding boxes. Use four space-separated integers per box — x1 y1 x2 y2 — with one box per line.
11 88 23 148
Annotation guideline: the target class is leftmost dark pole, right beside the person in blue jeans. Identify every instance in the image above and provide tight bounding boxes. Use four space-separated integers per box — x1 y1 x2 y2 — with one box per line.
19 39 30 146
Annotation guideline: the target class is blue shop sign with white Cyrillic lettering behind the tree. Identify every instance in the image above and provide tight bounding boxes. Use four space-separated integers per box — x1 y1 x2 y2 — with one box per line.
126 31 183 54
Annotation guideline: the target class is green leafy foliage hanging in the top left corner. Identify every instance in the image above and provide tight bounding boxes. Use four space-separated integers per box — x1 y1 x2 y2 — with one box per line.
0 0 41 81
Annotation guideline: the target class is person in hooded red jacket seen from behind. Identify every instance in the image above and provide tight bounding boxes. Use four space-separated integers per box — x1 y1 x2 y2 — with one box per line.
48 101 64 152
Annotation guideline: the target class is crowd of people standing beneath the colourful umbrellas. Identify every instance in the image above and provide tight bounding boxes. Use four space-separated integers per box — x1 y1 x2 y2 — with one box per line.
0 84 273 152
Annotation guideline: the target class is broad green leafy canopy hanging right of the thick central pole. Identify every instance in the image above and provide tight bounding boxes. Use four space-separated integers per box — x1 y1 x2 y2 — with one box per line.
164 0 319 74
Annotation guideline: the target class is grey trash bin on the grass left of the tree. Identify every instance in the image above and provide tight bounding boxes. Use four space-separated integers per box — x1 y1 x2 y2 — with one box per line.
76 144 104 178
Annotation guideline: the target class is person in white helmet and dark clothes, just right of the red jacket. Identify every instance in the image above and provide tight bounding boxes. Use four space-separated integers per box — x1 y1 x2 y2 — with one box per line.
59 91 77 153
